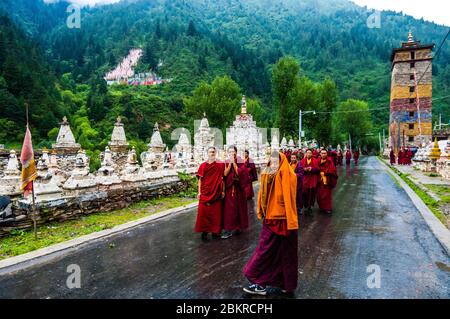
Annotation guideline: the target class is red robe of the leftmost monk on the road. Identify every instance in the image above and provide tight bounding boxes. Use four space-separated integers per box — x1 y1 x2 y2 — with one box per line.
195 162 225 234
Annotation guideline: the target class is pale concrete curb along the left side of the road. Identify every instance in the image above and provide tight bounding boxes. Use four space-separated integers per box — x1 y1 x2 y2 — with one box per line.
0 202 198 275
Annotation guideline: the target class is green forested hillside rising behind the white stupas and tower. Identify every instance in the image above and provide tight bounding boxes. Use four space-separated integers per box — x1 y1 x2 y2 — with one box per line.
0 0 450 159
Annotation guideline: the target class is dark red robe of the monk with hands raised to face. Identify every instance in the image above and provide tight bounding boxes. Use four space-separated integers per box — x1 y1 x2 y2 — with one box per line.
223 160 250 231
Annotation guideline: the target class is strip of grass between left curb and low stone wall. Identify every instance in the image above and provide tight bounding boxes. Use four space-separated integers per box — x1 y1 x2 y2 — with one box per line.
0 195 196 260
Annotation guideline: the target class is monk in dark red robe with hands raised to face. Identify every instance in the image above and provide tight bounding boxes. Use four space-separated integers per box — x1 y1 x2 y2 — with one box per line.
222 146 250 239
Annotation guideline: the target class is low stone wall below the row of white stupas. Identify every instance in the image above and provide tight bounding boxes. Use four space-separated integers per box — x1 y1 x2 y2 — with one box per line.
0 178 188 237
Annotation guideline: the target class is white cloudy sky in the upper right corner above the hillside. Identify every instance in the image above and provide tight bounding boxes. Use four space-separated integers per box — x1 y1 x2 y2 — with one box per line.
352 0 450 26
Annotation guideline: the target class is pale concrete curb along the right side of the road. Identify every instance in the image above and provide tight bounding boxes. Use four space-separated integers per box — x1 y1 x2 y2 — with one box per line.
377 157 450 256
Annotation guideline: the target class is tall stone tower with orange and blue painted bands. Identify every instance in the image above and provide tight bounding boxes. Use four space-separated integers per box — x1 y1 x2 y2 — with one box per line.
389 31 434 153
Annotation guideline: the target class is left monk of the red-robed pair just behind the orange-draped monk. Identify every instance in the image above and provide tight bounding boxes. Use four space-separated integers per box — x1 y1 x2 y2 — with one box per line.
301 150 319 212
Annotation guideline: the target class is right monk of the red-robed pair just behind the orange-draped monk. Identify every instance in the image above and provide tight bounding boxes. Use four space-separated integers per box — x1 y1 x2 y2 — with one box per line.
317 151 338 213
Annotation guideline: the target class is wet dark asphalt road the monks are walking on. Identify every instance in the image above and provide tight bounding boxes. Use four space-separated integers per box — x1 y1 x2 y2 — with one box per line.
0 157 450 299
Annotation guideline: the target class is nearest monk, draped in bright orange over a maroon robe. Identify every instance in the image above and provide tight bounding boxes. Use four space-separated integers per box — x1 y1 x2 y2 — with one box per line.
243 152 298 295
